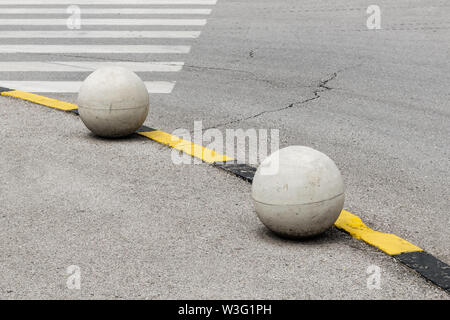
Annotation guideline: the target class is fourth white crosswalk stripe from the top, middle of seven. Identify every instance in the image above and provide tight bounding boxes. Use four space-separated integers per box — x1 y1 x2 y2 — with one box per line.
0 30 200 39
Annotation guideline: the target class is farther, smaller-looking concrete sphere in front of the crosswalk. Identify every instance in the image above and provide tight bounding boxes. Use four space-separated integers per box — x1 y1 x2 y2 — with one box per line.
78 67 149 138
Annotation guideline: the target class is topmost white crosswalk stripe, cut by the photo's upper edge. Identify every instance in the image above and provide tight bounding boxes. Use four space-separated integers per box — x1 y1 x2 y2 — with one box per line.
0 0 217 6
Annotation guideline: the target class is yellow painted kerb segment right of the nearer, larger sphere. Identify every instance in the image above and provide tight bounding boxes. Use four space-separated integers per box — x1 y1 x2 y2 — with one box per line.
334 210 423 255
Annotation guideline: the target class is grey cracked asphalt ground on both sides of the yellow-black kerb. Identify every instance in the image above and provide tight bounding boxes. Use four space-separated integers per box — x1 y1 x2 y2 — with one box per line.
0 0 450 299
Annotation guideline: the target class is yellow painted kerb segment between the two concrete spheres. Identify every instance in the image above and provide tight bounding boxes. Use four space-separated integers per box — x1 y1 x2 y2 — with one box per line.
138 130 234 163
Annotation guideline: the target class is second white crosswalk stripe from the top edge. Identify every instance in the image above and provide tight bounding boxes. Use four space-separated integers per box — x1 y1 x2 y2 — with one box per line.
0 8 211 15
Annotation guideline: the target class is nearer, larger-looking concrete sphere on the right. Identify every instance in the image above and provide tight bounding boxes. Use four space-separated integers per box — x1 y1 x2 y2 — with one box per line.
252 146 344 238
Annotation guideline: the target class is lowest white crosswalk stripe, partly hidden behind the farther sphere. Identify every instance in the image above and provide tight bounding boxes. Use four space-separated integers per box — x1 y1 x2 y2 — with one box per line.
0 80 175 93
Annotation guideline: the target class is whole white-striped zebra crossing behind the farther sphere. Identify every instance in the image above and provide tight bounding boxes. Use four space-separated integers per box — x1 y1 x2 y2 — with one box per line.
0 0 217 94
